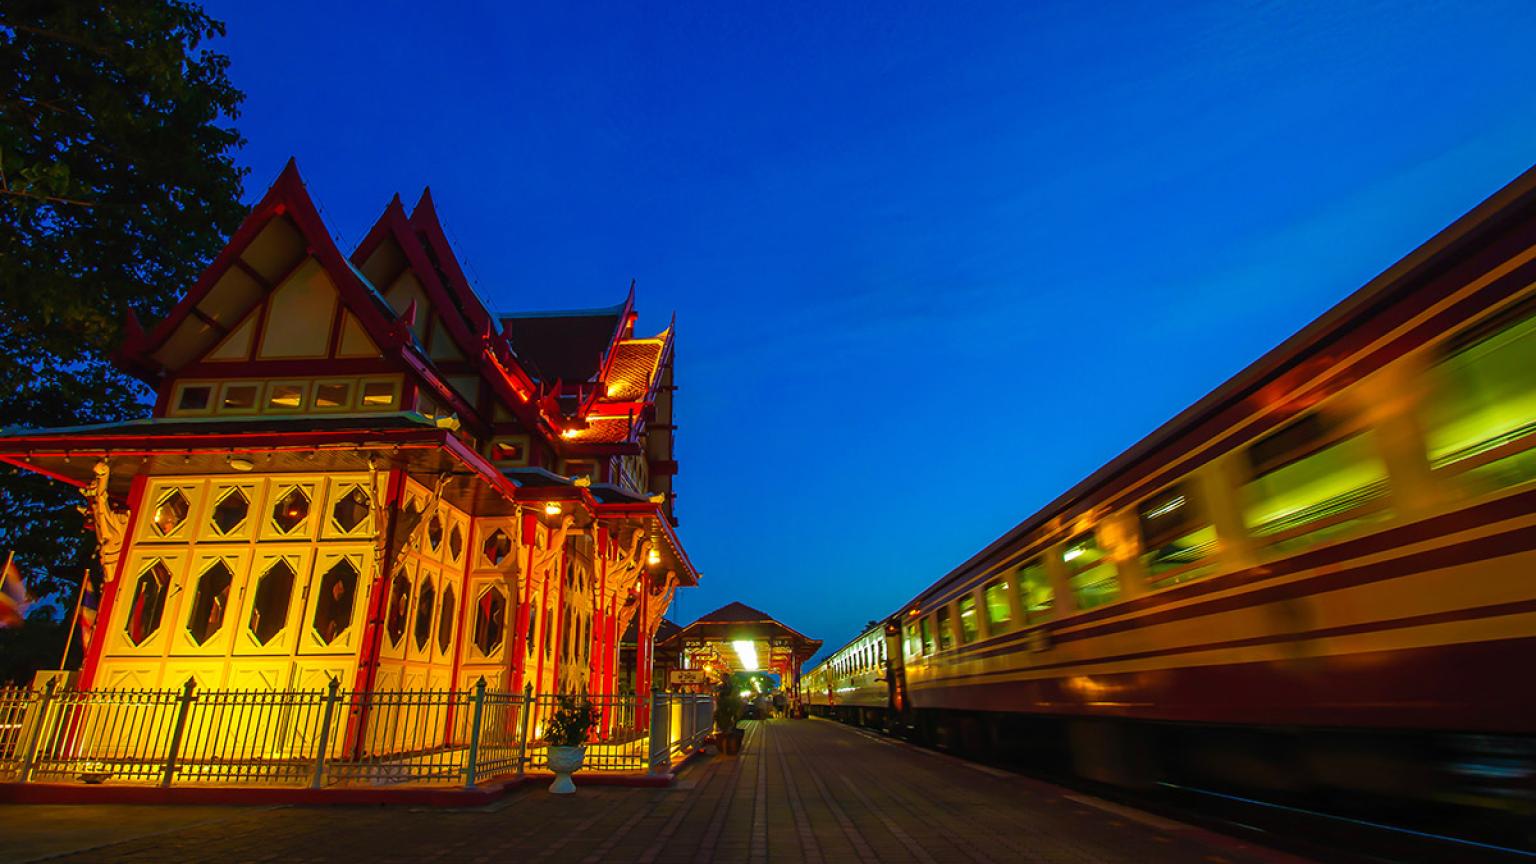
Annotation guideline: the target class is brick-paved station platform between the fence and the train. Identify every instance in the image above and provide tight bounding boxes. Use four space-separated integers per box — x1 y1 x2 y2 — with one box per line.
0 719 1296 864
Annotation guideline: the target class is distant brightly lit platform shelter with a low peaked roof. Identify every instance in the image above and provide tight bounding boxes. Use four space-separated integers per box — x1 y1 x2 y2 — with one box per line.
656 603 822 693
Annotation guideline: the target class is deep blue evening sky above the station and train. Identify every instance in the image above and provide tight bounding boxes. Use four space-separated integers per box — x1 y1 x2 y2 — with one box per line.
209 0 1536 657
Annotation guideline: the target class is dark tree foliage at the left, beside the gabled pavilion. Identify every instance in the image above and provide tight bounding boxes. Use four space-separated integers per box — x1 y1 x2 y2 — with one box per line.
0 0 244 603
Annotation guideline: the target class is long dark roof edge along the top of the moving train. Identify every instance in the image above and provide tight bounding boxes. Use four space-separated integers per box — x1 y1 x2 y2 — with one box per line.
891 158 1536 608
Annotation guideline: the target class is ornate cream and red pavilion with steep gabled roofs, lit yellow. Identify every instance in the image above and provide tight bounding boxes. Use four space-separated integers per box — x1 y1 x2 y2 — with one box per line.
0 163 697 695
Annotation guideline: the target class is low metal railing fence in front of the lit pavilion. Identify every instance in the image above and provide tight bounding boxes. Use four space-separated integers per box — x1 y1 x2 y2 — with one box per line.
0 681 713 789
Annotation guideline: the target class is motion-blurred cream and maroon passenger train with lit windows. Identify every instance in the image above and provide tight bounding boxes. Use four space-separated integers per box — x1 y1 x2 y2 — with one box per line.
802 169 1536 846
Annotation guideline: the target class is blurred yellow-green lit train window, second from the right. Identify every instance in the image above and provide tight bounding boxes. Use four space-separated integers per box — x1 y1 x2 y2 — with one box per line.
1244 414 1389 550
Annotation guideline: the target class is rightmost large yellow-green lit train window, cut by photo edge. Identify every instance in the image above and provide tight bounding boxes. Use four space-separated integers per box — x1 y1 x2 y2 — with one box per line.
1425 301 1536 490
